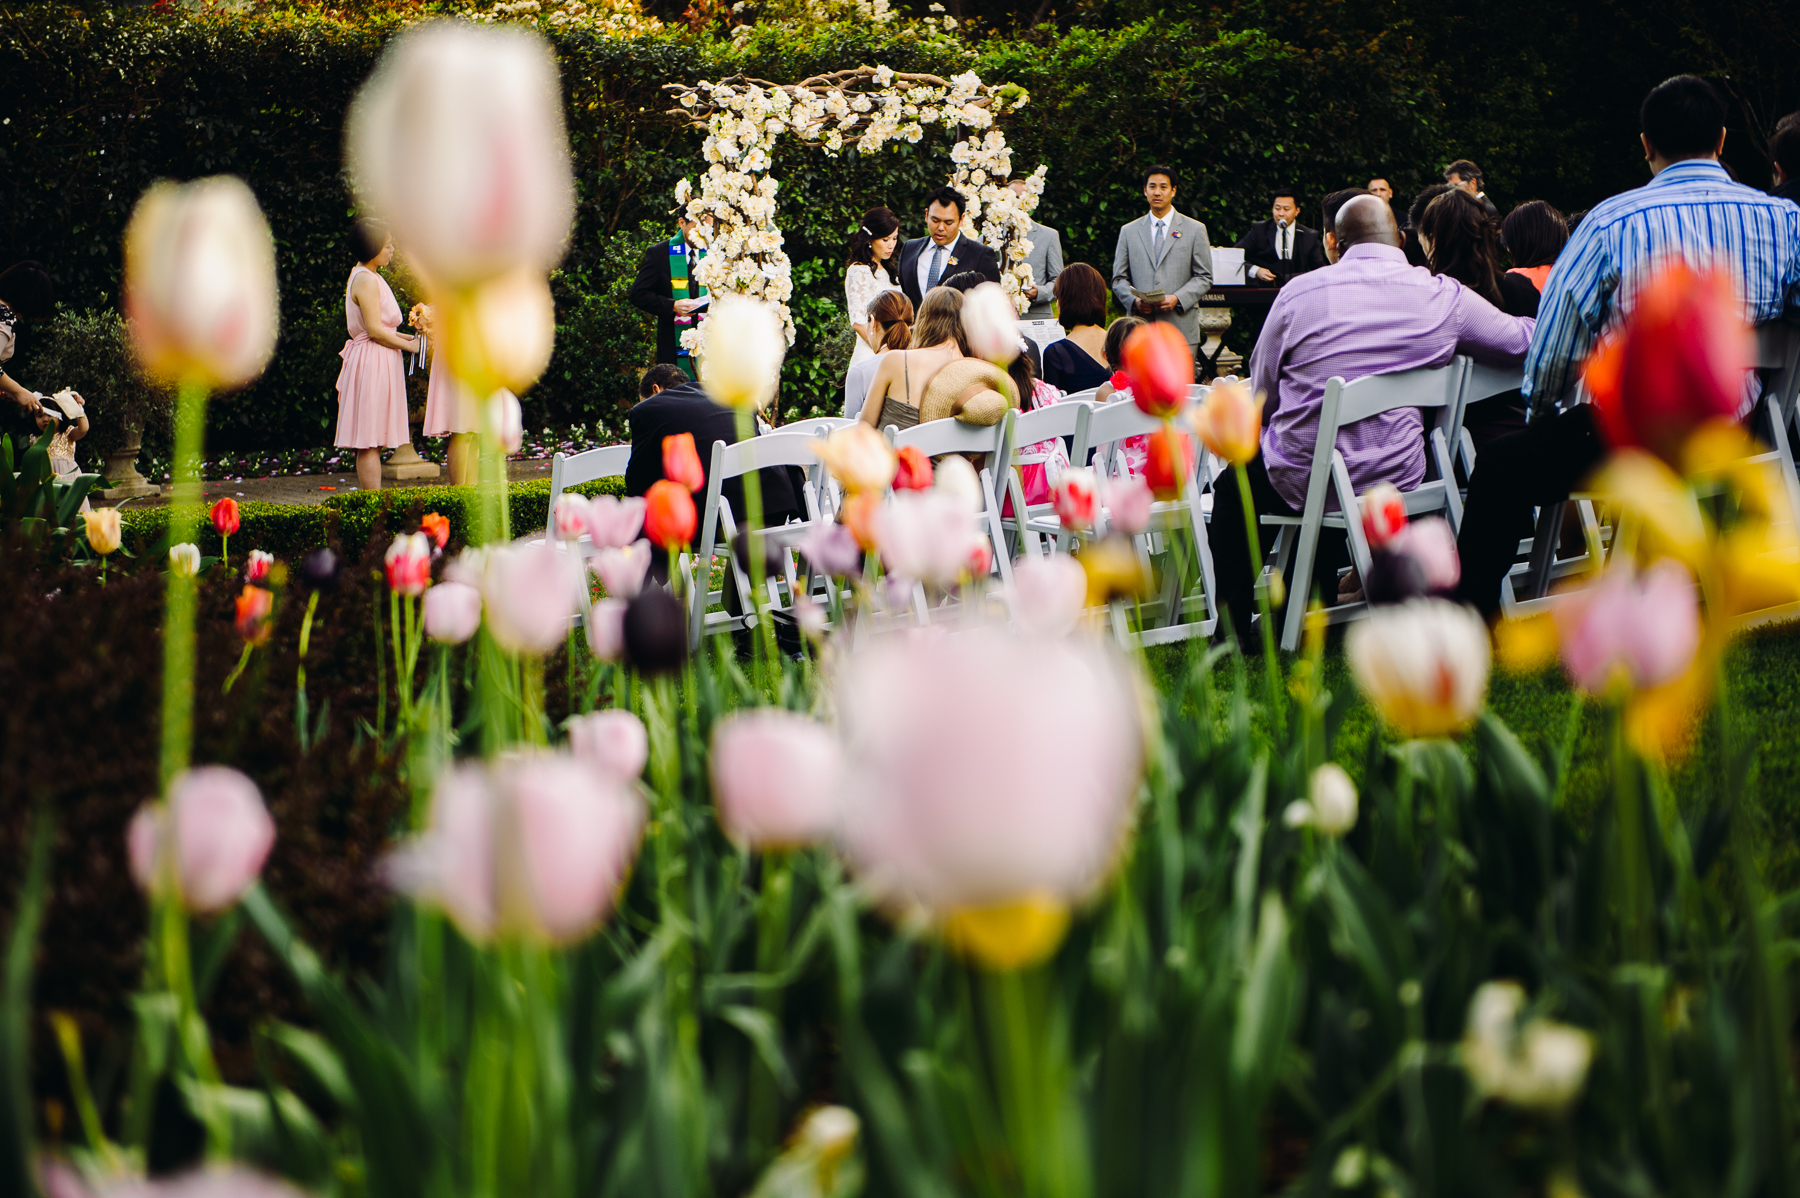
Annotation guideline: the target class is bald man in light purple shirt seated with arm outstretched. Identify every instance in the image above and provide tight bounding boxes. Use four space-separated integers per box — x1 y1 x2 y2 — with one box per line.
1210 194 1534 644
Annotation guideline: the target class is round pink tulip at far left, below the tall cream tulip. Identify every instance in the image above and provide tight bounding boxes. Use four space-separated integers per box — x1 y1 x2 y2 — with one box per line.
126 766 275 916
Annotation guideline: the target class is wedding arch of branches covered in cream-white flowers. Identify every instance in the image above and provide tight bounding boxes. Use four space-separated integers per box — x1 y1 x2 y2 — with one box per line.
664 67 1046 344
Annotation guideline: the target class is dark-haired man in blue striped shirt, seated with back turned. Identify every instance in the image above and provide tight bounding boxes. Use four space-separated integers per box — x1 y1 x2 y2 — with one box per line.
1458 76 1800 619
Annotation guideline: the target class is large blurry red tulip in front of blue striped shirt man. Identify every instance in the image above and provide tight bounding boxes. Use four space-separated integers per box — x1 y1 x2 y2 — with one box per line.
1582 259 1755 464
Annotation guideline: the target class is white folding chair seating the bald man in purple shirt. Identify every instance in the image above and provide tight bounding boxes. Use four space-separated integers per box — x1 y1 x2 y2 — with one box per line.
1262 356 1469 653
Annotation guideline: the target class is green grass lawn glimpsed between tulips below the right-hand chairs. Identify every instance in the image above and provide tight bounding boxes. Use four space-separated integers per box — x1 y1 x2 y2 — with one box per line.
1150 622 1800 890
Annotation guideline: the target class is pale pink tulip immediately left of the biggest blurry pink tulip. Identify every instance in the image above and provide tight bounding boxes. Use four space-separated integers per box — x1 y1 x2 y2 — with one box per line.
713 709 844 849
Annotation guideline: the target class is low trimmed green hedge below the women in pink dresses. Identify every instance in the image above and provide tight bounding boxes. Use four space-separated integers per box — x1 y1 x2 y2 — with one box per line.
122 478 625 561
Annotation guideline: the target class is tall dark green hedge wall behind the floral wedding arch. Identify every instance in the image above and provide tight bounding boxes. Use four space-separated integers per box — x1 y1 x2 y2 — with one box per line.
0 5 1444 448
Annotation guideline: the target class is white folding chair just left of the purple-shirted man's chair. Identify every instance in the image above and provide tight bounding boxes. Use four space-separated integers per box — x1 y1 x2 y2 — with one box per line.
1076 387 1219 644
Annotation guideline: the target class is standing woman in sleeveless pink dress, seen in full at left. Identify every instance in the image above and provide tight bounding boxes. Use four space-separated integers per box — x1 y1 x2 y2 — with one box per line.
337 219 419 491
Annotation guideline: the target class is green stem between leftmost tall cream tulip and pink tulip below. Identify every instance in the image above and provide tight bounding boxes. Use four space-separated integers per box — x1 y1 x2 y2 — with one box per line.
160 380 207 790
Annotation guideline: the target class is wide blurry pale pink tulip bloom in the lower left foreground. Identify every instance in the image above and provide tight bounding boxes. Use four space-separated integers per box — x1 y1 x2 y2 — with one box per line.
387 754 644 943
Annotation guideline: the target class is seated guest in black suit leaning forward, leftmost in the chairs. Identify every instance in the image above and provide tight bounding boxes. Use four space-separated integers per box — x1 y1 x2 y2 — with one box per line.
625 362 806 525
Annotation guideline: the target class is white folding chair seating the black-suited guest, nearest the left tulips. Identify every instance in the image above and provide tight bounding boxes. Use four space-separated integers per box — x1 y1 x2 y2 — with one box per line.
682 428 830 649
